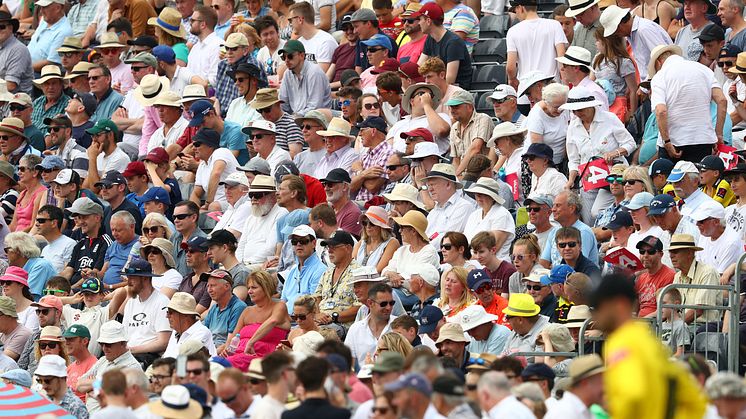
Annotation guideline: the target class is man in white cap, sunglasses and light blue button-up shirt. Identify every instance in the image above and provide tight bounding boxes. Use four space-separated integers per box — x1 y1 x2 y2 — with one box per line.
280 224 326 314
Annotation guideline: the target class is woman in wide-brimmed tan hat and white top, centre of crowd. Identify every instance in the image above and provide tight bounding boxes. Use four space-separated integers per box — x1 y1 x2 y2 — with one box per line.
381 211 440 307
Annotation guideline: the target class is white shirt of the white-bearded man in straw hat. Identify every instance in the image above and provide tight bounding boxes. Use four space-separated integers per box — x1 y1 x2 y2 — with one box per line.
236 205 288 265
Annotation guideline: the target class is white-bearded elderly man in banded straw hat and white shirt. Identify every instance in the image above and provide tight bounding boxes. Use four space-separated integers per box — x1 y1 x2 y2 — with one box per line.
236 175 288 264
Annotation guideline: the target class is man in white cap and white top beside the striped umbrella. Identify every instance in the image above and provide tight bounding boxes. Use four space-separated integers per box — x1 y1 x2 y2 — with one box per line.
77 320 142 413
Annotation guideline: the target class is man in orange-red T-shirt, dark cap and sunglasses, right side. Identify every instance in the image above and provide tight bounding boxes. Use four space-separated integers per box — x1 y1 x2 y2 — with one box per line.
635 236 675 317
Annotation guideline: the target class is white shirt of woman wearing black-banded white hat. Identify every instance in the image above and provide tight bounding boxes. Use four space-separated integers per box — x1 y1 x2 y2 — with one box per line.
567 107 637 172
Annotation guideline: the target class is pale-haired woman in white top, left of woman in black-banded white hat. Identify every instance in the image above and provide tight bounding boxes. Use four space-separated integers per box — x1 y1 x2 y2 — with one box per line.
524 83 570 170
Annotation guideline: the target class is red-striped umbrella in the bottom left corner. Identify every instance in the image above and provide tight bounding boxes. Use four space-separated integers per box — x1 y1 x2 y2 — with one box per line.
0 383 75 419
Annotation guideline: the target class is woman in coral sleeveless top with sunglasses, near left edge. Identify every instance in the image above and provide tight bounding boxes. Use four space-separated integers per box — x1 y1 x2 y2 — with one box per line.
8 154 47 233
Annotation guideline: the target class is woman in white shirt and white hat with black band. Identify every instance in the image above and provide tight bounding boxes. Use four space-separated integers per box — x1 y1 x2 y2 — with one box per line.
561 87 637 225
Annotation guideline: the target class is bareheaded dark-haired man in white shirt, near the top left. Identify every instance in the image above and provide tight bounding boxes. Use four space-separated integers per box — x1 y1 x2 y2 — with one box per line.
187 6 221 86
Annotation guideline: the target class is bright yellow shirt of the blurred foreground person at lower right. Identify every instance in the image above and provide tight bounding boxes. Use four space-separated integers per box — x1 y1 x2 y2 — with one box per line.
604 322 706 419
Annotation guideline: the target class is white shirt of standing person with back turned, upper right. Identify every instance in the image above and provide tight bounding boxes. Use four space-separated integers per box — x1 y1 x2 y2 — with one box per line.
648 55 720 147
